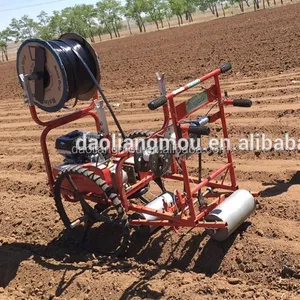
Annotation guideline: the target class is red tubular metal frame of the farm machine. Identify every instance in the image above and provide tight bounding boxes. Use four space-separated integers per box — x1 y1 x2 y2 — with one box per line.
30 65 255 228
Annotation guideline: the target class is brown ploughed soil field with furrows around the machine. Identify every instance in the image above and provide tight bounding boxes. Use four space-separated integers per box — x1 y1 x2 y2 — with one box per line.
0 4 300 300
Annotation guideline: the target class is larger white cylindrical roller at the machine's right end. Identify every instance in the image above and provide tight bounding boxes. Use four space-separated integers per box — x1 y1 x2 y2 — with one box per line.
205 190 256 241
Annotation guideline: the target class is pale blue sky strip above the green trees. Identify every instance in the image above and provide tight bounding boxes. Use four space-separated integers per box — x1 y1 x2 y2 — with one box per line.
0 0 124 30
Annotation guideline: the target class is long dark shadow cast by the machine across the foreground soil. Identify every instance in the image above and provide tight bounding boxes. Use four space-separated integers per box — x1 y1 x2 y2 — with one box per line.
0 222 251 299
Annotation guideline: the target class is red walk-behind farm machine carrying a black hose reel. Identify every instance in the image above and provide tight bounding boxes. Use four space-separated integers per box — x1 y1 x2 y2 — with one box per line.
17 33 256 255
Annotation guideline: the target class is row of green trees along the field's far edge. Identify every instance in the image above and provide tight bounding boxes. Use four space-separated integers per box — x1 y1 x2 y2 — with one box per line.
0 0 292 61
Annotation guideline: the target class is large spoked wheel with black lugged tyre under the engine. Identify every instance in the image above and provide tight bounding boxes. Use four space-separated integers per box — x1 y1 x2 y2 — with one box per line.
54 166 130 256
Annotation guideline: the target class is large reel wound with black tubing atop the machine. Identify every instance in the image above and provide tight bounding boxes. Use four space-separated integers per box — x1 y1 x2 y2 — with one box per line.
17 33 100 112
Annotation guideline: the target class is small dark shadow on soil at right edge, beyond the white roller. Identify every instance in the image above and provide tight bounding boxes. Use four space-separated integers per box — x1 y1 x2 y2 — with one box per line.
260 171 300 198
